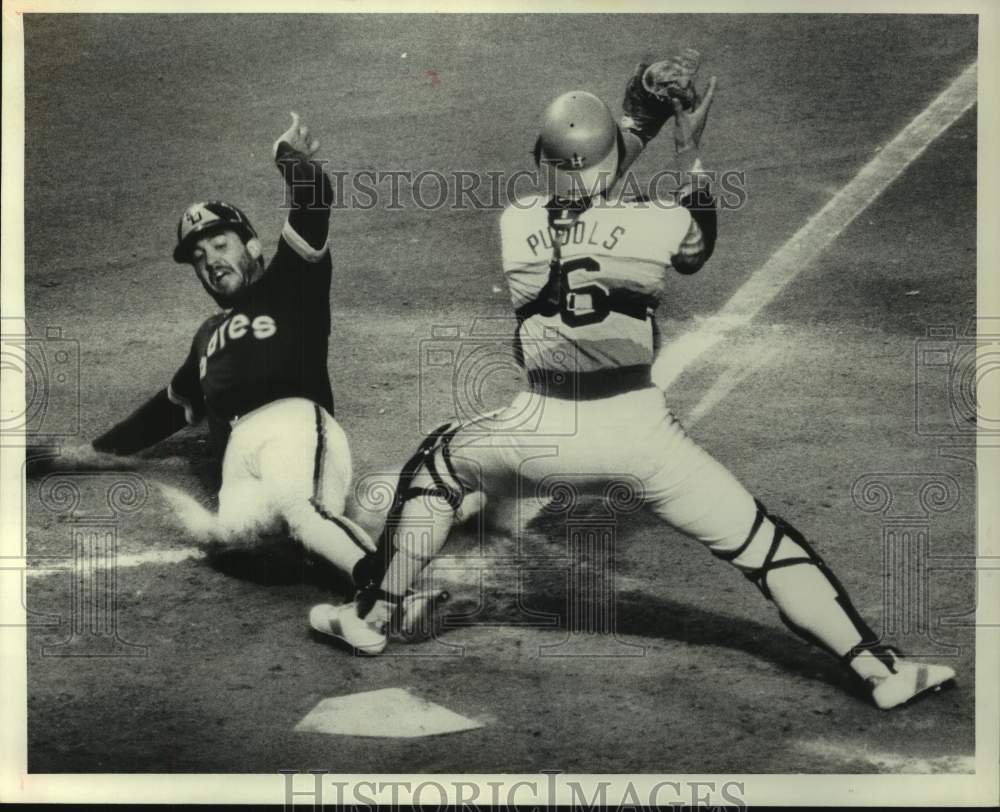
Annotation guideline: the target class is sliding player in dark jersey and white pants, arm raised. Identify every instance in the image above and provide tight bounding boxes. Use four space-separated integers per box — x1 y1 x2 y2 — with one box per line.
54 113 375 588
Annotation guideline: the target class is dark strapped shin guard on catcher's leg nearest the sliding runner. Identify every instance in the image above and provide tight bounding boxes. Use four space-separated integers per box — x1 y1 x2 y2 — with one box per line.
354 423 474 590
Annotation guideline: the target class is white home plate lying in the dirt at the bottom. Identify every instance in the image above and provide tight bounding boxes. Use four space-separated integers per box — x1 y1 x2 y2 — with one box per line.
295 688 483 739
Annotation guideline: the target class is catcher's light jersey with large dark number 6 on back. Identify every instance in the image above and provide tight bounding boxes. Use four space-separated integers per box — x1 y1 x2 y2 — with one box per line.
500 195 704 374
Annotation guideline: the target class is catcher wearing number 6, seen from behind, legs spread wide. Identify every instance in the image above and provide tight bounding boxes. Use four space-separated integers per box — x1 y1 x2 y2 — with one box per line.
310 54 954 709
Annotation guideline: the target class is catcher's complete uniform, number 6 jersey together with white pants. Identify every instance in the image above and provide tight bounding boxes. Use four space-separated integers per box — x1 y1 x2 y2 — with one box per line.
434 190 756 551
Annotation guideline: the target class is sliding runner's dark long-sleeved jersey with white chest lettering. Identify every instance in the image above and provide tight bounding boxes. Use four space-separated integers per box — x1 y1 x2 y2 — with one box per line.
93 142 333 454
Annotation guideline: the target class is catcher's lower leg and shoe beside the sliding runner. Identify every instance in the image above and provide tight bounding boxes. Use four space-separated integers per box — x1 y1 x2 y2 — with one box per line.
309 418 479 654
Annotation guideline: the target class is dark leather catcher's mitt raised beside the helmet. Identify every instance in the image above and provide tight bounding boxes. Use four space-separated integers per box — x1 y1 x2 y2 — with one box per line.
622 48 701 143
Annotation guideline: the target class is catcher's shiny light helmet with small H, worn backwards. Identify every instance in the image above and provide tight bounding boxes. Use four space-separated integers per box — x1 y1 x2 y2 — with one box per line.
535 90 624 197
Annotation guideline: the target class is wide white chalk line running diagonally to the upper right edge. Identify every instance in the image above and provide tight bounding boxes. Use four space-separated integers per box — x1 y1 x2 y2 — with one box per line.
653 62 977 402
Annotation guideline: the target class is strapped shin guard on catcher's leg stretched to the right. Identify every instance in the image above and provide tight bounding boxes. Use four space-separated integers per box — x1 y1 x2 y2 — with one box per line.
715 500 878 648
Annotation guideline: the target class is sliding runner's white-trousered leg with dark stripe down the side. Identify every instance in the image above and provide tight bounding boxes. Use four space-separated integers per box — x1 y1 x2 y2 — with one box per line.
259 404 375 573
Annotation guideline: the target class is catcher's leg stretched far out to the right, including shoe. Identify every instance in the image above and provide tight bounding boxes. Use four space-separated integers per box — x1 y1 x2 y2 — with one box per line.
653 427 954 708
